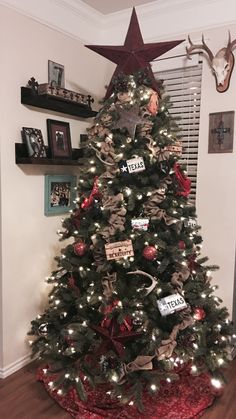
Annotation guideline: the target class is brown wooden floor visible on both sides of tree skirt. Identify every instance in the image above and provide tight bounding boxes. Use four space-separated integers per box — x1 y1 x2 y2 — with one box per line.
0 359 236 419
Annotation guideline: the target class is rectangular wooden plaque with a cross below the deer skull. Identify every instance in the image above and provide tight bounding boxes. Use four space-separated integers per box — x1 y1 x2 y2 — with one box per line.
208 111 234 153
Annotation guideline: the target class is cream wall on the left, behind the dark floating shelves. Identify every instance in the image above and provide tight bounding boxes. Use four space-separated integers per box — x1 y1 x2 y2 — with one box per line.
0 6 113 375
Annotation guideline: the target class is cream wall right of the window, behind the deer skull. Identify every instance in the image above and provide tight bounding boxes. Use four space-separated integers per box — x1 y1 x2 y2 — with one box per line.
197 25 236 313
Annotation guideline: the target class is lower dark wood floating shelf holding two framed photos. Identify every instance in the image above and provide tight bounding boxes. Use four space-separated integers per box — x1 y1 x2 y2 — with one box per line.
15 143 83 166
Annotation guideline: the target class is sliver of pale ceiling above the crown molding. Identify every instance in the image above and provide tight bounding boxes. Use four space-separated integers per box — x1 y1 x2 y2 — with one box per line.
82 0 154 15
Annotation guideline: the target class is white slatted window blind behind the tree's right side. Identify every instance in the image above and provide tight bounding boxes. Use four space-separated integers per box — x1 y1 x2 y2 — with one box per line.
155 64 202 204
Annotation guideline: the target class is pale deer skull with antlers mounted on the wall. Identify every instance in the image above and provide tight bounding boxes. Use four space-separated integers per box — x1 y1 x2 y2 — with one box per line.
186 32 236 93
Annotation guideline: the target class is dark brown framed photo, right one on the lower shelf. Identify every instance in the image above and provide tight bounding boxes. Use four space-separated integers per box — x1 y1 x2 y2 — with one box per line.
47 119 72 159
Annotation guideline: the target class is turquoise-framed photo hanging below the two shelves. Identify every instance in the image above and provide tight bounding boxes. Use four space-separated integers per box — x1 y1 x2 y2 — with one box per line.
44 175 76 215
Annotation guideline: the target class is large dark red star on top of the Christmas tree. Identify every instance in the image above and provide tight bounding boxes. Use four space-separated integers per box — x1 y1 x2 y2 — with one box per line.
86 8 183 99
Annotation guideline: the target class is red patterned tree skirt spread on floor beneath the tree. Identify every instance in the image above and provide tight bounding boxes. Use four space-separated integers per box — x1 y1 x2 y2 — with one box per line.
37 368 220 419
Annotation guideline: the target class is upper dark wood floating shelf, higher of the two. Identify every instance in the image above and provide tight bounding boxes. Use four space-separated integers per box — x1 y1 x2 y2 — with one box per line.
21 87 97 118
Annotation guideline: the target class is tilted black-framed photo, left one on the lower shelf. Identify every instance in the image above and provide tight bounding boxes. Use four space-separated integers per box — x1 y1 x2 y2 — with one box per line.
21 127 46 158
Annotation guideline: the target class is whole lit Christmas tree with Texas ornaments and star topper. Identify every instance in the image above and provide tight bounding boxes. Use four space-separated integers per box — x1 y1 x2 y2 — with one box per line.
30 10 231 417
